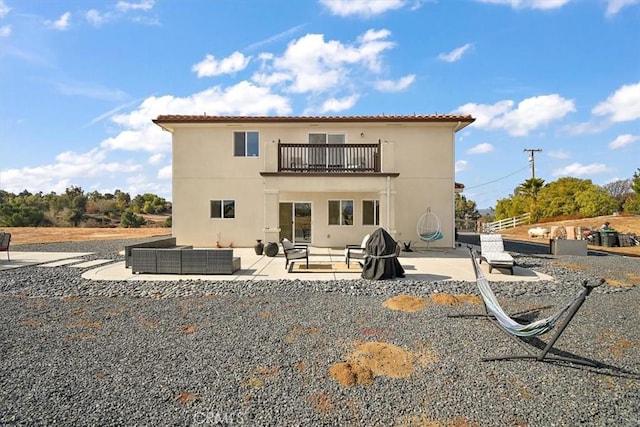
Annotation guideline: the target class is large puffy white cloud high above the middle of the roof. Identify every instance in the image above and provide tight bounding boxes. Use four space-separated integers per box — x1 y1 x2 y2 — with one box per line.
254 30 395 93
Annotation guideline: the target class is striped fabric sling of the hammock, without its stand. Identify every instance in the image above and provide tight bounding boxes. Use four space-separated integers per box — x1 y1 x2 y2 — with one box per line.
469 249 584 337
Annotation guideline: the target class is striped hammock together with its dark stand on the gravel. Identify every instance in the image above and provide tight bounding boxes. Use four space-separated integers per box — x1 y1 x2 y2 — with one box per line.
450 247 604 367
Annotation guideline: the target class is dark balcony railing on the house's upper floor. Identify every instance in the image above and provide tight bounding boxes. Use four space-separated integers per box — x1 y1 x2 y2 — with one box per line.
278 141 382 174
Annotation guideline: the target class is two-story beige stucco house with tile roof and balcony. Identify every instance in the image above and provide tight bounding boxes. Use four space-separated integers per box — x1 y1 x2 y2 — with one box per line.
154 115 474 251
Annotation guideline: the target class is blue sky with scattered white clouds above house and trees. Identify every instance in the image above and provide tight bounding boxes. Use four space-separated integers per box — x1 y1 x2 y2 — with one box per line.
0 0 640 208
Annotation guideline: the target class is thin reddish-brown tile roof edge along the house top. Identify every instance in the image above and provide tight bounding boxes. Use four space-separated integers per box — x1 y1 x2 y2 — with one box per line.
153 114 475 124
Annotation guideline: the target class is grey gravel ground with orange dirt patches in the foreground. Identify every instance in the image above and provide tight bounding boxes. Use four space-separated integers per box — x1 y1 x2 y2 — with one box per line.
0 239 640 426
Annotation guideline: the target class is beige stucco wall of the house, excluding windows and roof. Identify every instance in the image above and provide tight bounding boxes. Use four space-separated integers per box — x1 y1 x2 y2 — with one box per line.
173 123 455 247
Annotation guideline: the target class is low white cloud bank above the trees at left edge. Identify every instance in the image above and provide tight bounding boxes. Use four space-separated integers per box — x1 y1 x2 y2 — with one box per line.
2 148 141 193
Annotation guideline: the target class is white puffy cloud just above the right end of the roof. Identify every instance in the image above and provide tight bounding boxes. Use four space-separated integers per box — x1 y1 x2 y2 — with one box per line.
455 94 576 136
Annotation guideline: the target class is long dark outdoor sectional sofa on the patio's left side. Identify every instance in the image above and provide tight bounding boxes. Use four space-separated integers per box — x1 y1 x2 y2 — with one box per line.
131 247 241 274
